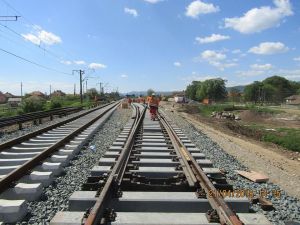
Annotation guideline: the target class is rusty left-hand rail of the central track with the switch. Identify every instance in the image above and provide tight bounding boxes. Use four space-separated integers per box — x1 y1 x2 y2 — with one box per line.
83 105 146 225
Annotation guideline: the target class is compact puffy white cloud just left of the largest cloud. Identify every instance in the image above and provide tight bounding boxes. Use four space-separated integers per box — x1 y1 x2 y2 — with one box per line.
185 0 220 18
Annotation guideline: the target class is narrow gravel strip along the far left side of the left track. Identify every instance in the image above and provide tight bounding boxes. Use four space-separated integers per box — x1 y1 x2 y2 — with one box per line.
0 110 91 143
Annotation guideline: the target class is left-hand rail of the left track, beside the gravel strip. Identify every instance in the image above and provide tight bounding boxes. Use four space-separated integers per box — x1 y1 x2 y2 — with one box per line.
0 103 113 152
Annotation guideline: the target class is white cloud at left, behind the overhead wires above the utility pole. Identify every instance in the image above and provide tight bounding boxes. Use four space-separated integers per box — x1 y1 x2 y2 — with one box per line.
21 25 62 45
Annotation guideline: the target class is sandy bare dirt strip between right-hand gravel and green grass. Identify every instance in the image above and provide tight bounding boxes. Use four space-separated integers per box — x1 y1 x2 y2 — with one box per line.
161 102 300 199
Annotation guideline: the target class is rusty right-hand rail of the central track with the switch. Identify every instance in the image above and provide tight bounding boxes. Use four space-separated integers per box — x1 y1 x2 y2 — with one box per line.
159 113 243 225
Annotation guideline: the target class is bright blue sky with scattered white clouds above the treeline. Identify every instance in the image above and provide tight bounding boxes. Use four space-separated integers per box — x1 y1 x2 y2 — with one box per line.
0 0 300 94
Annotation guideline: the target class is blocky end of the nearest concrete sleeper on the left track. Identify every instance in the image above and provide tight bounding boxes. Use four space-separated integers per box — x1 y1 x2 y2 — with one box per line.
0 199 28 223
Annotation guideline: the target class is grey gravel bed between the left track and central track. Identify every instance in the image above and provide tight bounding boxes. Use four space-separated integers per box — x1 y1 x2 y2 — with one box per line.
13 109 132 225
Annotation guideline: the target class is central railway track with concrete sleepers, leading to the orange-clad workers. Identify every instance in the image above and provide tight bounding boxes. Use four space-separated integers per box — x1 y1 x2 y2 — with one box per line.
50 104 270 225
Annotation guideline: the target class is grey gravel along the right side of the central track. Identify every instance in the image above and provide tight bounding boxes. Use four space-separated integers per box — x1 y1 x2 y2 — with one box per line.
165 111 300 225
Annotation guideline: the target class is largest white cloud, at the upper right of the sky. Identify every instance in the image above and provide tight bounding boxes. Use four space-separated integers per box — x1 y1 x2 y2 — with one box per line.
225 0 293 34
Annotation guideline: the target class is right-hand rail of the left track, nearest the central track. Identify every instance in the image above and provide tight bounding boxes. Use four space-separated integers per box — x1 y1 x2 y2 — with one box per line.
0 102 120 193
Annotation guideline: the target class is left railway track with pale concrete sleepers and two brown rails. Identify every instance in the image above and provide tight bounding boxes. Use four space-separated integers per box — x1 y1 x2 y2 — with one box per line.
0 102 119 224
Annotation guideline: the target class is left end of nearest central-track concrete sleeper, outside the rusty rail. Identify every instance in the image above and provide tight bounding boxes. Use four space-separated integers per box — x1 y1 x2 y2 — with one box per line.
50 211 85 225
